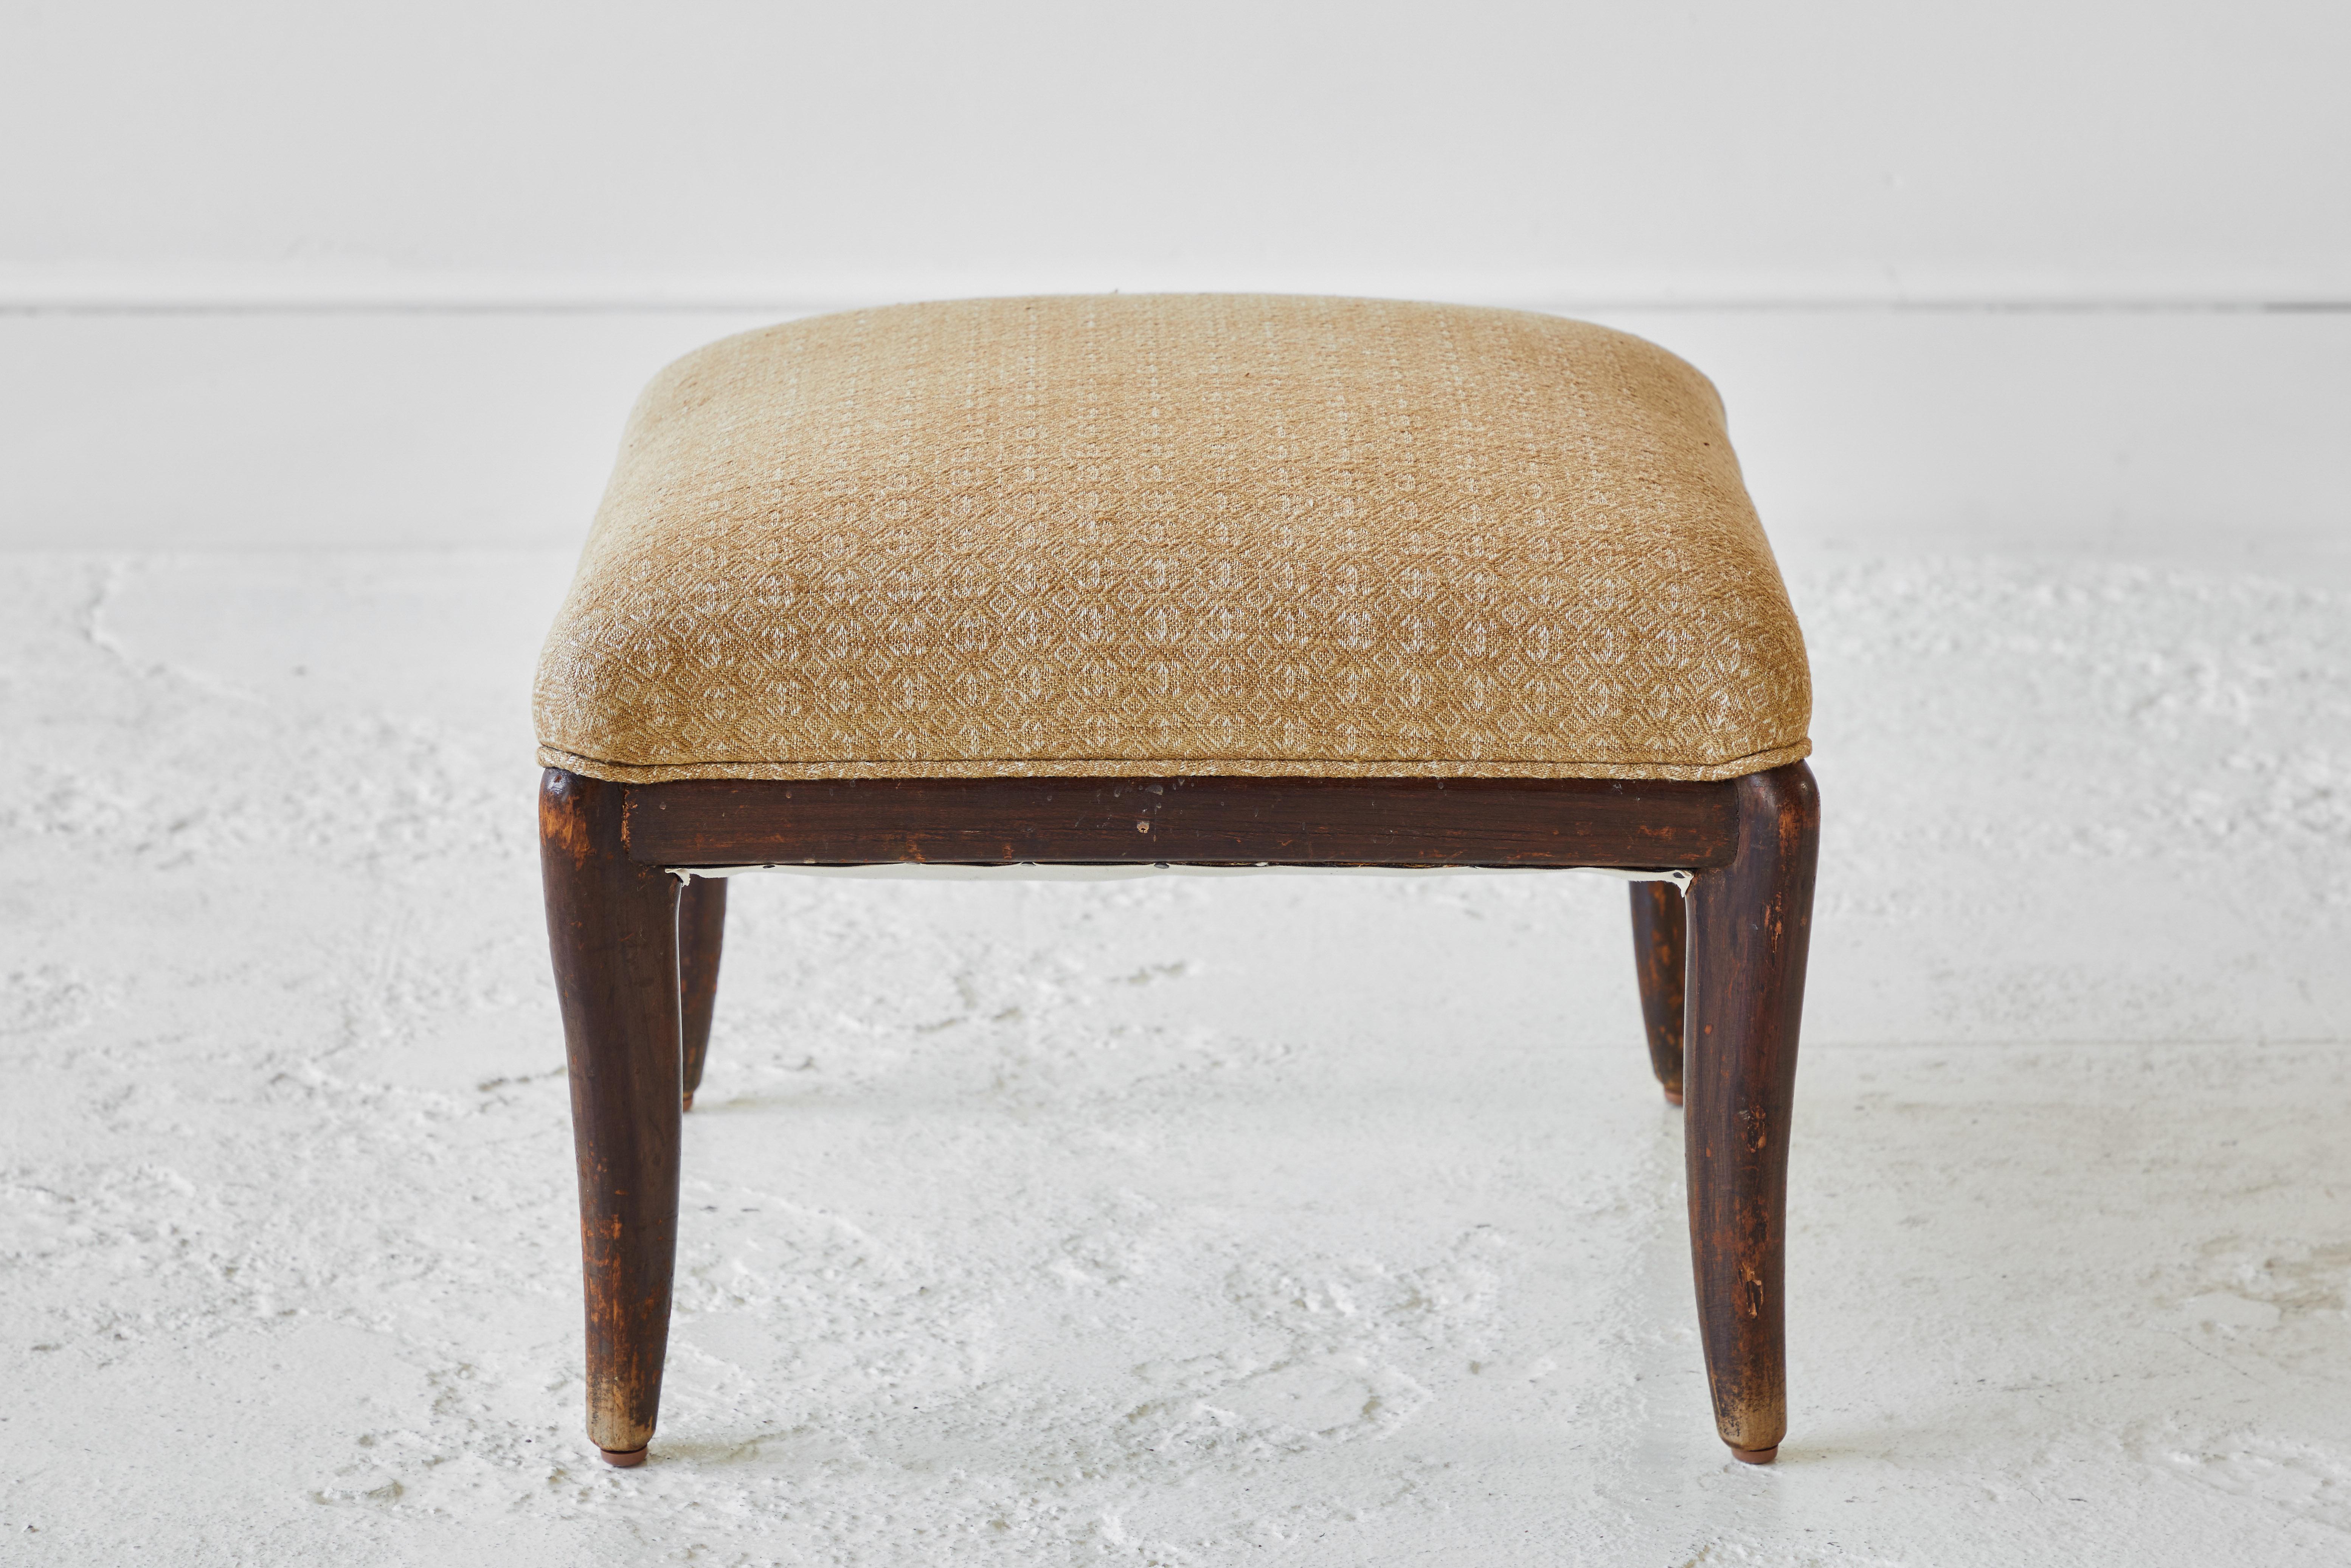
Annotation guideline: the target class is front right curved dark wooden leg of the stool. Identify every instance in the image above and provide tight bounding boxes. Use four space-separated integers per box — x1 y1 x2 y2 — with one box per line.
1683 762 1820 1465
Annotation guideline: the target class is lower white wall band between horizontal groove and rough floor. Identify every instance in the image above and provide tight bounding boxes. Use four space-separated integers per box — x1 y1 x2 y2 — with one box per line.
0 310 2351 562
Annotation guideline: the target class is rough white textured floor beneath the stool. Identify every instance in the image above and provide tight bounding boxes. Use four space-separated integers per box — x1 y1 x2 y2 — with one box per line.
0 555 2351 1568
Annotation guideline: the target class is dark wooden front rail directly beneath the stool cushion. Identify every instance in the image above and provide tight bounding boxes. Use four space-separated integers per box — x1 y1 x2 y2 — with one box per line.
628 778 1737 870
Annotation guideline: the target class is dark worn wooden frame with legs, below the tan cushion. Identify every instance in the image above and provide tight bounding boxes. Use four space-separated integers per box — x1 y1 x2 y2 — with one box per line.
538 762 1820 1465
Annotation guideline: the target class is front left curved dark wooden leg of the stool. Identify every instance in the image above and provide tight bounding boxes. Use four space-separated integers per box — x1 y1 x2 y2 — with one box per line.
538 769 682 1465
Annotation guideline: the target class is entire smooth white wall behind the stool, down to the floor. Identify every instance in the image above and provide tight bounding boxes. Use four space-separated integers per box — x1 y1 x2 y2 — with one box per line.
0 0 2351 548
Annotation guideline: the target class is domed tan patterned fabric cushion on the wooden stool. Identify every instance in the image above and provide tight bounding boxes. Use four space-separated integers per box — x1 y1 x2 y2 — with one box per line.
536 294 1810 781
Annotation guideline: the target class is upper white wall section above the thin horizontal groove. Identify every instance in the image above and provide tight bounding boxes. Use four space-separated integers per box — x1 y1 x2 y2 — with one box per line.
0 0 2351 306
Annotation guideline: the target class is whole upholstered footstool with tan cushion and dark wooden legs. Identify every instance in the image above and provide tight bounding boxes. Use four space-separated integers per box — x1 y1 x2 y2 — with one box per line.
536 296 1820 1465
